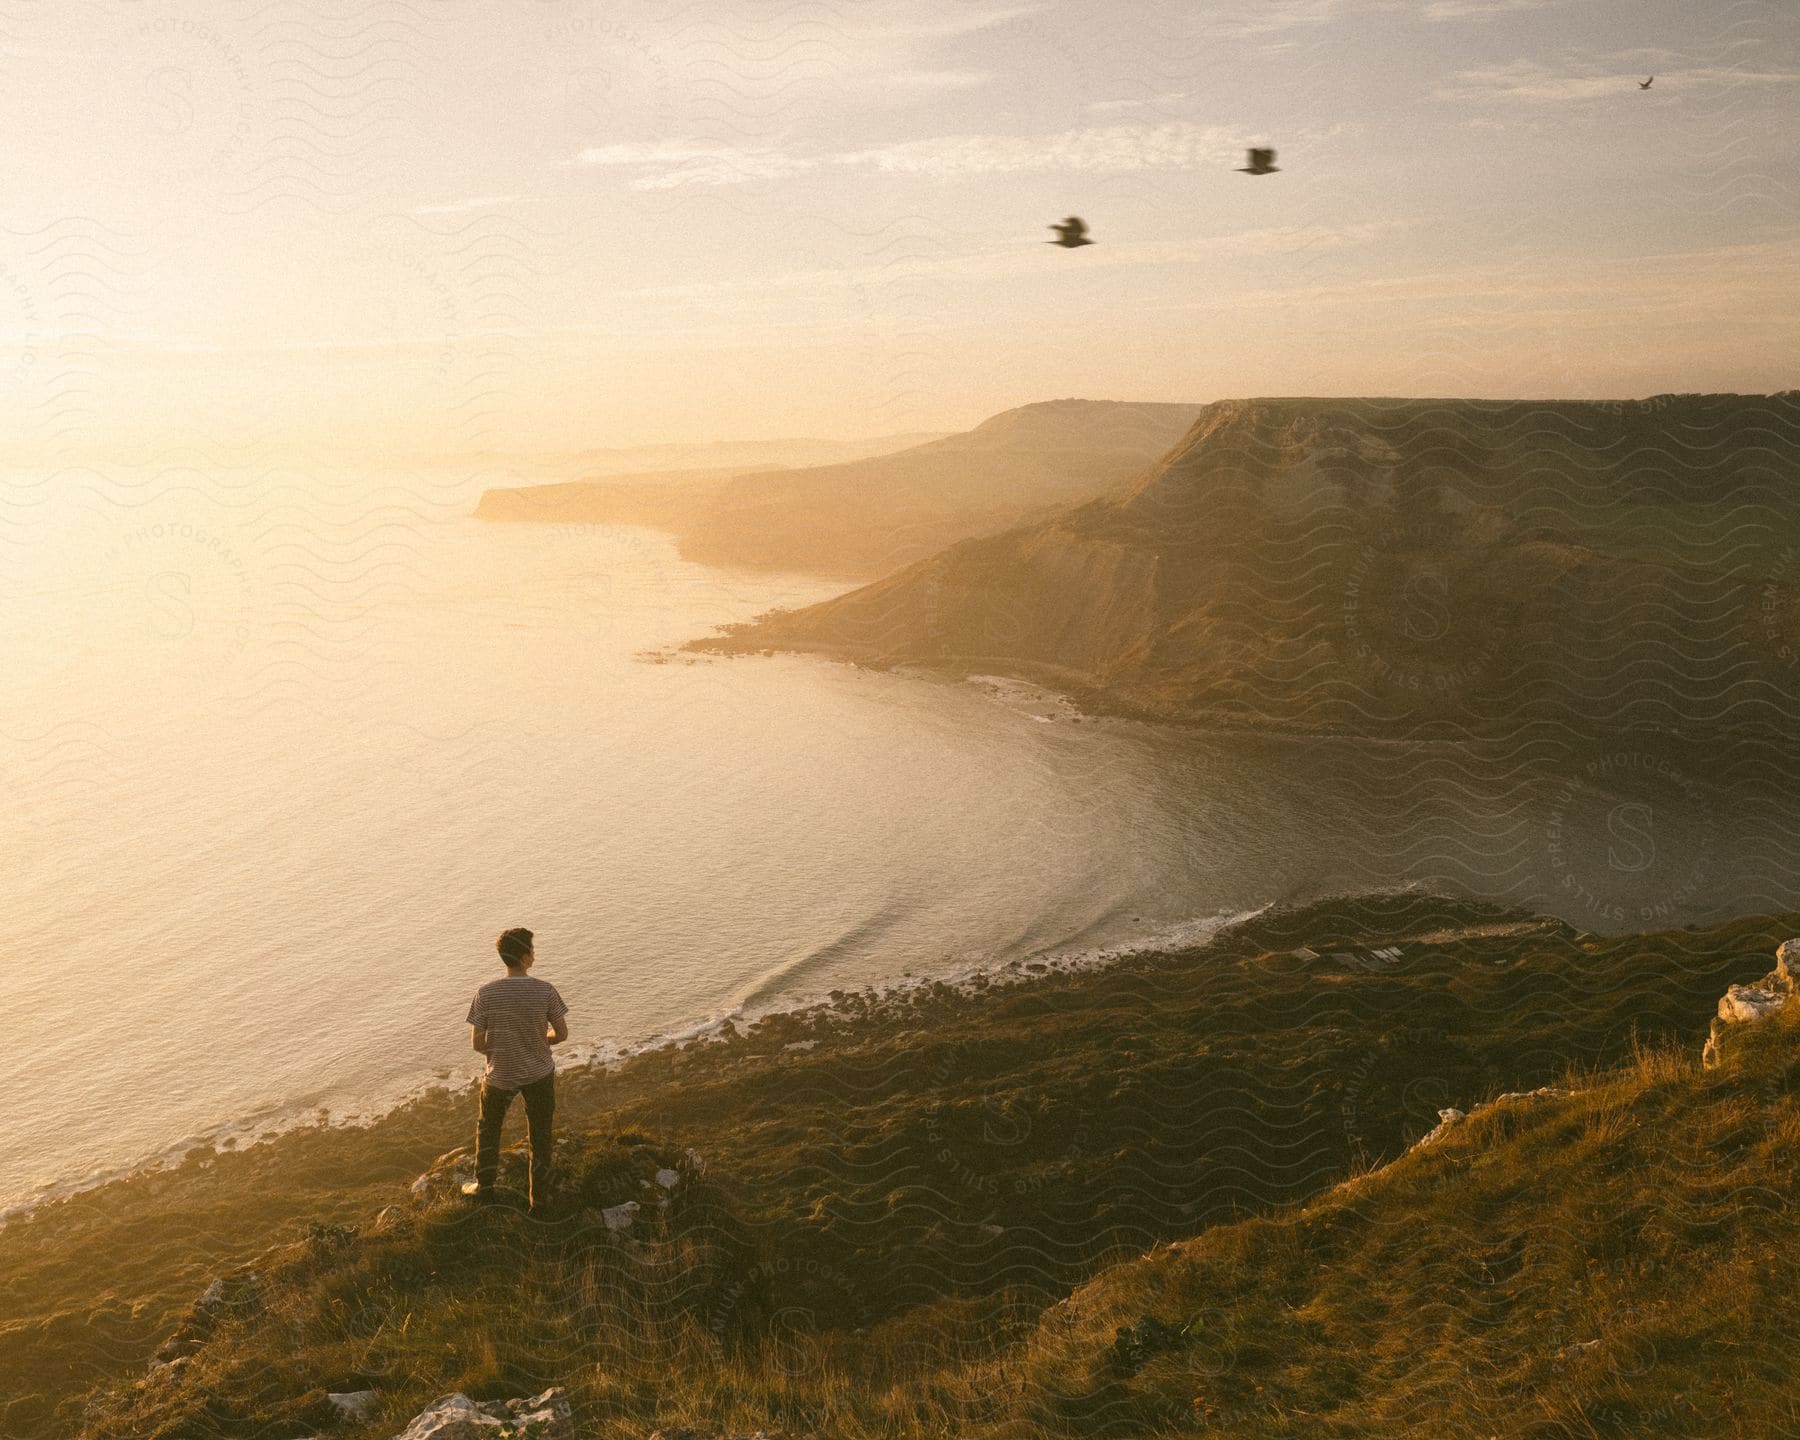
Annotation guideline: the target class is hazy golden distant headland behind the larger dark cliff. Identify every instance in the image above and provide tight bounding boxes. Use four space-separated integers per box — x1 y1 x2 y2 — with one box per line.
475 400 1201 580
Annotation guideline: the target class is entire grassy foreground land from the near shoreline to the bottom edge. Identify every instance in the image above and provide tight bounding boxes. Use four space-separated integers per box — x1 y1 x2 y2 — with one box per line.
0 896 1800 1440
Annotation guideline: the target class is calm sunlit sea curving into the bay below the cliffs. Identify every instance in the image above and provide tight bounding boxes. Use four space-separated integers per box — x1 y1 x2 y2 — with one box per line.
0 464 1800 1213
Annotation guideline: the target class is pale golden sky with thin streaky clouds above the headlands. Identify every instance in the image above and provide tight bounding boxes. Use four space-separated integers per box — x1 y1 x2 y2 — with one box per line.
0 0 1800 464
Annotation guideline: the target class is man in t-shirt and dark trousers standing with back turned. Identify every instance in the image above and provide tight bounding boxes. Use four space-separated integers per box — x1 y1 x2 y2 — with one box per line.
468 929 569 1215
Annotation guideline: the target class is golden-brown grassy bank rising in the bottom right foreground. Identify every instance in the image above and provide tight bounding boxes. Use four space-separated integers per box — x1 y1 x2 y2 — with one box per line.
1021 986 1800 1440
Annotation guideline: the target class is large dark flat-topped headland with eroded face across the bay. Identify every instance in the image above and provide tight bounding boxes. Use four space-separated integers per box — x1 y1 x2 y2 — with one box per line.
720 394 1800 734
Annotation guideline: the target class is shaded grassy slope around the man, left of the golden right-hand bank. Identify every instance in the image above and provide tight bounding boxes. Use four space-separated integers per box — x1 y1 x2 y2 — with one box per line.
31 896 1795 1440
